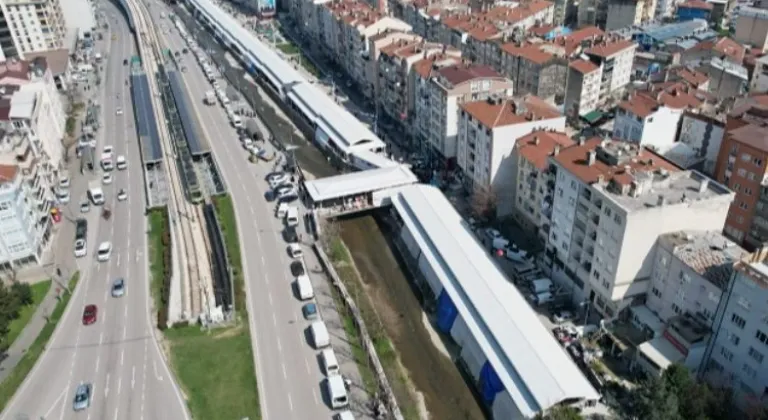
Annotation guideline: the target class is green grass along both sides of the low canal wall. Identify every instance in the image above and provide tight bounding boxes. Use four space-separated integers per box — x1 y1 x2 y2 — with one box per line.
328 238 419 419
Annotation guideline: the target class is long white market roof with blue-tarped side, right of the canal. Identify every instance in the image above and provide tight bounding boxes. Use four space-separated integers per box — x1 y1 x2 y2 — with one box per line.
392 185 600 417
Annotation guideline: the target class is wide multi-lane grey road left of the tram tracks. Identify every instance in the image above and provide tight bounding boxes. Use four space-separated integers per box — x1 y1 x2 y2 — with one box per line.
0 2 188 420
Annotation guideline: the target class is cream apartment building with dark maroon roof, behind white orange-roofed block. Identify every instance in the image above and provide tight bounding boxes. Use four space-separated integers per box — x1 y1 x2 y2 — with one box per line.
416 64 513 161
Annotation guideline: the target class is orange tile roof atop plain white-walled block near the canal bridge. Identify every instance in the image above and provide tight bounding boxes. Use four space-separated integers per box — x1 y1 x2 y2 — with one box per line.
461 95 561 128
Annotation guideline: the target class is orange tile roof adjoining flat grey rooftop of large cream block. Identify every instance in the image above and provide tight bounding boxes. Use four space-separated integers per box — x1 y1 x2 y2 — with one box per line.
553 137 680 185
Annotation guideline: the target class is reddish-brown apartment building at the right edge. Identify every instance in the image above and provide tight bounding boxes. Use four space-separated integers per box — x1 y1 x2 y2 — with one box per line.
715 95 768 250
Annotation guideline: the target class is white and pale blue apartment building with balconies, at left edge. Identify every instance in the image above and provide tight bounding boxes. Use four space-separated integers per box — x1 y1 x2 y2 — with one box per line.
0 133 53 271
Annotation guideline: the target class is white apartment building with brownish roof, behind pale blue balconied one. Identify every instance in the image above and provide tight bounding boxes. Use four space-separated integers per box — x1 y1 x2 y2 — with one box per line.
0 58 66 174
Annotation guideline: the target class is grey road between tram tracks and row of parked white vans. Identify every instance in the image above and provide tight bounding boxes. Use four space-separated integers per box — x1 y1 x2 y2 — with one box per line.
151 3 376 420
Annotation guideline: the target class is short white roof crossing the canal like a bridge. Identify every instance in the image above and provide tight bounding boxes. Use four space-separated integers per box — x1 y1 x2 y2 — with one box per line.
304 165 419 202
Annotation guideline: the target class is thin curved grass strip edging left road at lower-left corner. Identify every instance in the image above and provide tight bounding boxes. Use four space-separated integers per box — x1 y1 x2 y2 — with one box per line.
0 271 80 411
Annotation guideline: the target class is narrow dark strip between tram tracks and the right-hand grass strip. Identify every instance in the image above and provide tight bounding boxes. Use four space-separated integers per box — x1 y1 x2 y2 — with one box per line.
203 202 235 312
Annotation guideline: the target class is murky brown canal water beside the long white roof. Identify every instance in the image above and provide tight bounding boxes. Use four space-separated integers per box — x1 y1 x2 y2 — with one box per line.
342 216 485 420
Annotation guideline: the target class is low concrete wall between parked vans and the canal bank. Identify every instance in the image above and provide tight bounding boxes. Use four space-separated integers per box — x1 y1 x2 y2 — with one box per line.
312 243 404 420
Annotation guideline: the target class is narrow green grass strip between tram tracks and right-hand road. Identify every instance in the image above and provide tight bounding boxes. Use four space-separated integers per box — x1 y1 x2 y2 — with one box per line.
212 195 247 319
